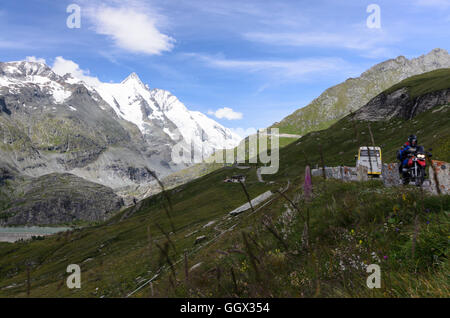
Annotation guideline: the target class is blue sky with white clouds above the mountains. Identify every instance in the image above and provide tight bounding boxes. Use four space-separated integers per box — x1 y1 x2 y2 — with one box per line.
0 0 450 134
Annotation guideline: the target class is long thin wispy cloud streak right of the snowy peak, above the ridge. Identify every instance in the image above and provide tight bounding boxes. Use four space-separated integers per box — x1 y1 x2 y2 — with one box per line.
191 53 348 78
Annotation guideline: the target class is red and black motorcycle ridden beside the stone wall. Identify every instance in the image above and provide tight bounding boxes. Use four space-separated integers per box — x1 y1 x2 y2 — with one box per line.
402 146 432 187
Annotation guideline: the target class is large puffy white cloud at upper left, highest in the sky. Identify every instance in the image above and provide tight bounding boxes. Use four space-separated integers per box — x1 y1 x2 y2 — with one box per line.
88 5 175 55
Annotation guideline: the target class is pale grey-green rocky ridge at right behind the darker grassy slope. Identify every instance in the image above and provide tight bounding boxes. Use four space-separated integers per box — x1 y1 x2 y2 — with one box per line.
273 49 450 135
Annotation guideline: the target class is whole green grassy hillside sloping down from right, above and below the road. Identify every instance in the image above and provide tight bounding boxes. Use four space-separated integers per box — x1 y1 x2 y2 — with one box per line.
0 105 450 297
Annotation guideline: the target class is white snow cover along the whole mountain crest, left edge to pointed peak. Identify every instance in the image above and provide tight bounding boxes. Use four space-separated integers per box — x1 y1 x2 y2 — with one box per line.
0 61 241 160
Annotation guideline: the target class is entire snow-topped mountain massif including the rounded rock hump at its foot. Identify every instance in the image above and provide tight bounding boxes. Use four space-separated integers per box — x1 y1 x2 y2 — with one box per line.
0 61 243 225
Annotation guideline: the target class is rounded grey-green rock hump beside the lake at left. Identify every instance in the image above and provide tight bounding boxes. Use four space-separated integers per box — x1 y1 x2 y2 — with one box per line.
0 173 123 225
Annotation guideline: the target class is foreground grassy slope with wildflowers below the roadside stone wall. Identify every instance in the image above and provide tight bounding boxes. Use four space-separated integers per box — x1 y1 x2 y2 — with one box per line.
149 178 450 297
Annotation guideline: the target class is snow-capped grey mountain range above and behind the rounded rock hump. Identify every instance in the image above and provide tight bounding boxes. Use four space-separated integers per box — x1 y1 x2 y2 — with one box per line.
0 61 240 195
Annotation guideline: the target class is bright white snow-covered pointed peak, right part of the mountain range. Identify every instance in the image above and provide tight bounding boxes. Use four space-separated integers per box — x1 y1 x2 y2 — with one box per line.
95 73 241 156
